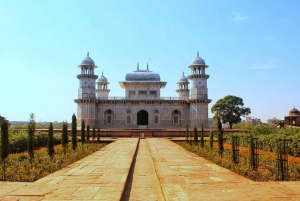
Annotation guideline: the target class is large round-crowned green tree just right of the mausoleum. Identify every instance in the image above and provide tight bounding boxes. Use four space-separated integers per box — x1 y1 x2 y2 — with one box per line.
211 95 251 129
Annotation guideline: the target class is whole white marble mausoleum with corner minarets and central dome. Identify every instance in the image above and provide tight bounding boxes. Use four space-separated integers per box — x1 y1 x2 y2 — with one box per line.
74 52 211 129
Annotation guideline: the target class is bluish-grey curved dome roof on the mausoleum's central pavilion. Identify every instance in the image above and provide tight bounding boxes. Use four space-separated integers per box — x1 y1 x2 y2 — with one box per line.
125 70 160 81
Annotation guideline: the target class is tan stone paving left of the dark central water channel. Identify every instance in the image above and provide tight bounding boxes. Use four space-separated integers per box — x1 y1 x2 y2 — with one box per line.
0 138 138 200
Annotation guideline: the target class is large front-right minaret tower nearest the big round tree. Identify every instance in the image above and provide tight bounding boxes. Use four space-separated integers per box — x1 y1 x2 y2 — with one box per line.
188 52 211 128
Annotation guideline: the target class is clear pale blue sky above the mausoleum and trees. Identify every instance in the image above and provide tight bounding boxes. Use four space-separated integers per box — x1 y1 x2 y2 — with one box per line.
0 0 300 122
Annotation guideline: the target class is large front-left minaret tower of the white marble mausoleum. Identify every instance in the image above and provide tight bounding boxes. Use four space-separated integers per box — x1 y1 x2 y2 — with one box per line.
74 53 98 127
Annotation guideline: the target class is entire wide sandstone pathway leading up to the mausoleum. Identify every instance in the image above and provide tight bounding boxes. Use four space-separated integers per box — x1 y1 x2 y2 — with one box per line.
0 138 300 201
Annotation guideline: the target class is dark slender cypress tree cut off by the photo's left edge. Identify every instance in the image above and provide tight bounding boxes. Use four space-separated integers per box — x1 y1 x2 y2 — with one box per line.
1 119 9 181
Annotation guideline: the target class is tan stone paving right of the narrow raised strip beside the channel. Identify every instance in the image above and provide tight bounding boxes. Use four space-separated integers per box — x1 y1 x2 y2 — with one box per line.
147 138 300 201
